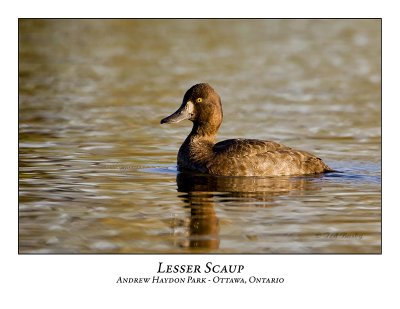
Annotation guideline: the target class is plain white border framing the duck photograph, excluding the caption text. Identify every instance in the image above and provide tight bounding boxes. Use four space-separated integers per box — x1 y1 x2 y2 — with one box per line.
0 0 400 308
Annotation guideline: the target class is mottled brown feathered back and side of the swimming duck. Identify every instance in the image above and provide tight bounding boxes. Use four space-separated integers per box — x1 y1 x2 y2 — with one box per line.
206 139 331 176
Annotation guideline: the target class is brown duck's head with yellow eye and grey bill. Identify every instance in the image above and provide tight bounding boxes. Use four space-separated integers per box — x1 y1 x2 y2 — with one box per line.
161 83 222 133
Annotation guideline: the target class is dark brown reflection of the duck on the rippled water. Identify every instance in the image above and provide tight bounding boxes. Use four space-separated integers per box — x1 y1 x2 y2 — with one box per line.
173 172 323 252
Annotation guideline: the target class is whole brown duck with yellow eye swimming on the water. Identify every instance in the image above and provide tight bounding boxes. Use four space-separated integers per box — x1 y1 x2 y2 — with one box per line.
161 83 333 176
